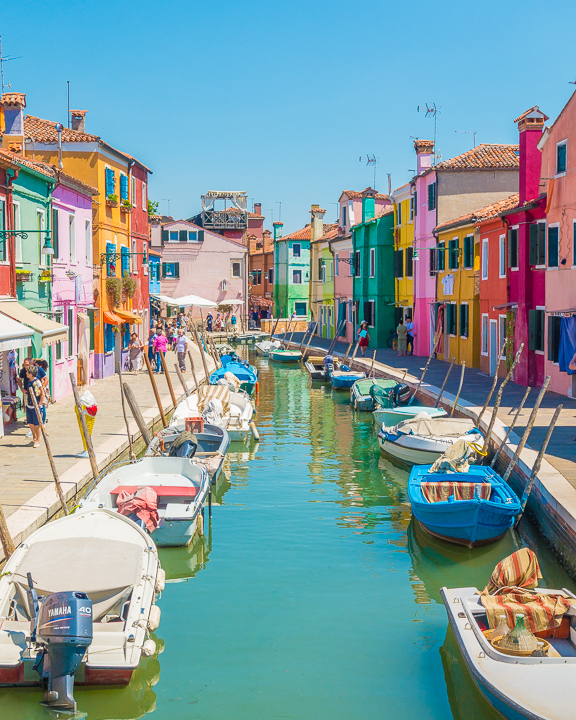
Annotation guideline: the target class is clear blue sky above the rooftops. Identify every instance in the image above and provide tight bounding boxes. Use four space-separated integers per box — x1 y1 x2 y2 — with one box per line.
0 0 576 234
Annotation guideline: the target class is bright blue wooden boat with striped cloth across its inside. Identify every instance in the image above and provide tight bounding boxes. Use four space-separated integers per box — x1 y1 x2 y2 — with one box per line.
408 465 520 548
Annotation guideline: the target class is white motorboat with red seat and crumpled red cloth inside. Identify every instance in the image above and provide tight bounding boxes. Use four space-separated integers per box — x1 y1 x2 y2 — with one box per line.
80 457 211 547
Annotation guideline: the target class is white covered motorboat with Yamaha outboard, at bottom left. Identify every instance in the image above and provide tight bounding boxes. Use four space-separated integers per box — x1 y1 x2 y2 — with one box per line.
0 509 165 711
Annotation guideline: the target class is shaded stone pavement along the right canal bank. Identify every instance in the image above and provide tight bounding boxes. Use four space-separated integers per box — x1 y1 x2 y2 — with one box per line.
288 333 576 488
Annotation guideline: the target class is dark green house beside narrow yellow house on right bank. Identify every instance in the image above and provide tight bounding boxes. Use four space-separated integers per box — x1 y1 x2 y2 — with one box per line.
351 194 396 347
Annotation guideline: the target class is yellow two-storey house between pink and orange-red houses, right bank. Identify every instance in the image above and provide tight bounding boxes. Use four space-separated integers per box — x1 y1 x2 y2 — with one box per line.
434 213 480 368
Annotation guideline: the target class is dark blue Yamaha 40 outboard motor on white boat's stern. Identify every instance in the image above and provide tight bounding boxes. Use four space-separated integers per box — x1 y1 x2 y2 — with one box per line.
28 573 92 712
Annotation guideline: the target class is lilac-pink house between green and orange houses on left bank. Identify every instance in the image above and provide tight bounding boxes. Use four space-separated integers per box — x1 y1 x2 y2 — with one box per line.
52 169 100 400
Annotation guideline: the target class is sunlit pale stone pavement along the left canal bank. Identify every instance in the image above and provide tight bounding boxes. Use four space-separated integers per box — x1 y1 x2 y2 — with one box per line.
0 346 214 531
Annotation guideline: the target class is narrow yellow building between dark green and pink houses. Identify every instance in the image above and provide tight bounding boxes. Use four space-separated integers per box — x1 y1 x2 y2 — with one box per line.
392 183 414 320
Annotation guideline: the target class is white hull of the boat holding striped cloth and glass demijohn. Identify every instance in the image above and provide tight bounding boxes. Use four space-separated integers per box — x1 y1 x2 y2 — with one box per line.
440 587 576 720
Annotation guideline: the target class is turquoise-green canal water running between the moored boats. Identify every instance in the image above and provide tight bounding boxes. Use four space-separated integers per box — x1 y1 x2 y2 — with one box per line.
0 358 574 720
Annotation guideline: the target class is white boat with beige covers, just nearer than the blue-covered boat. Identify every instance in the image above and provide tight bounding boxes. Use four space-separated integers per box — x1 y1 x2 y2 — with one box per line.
170 385 254 442
